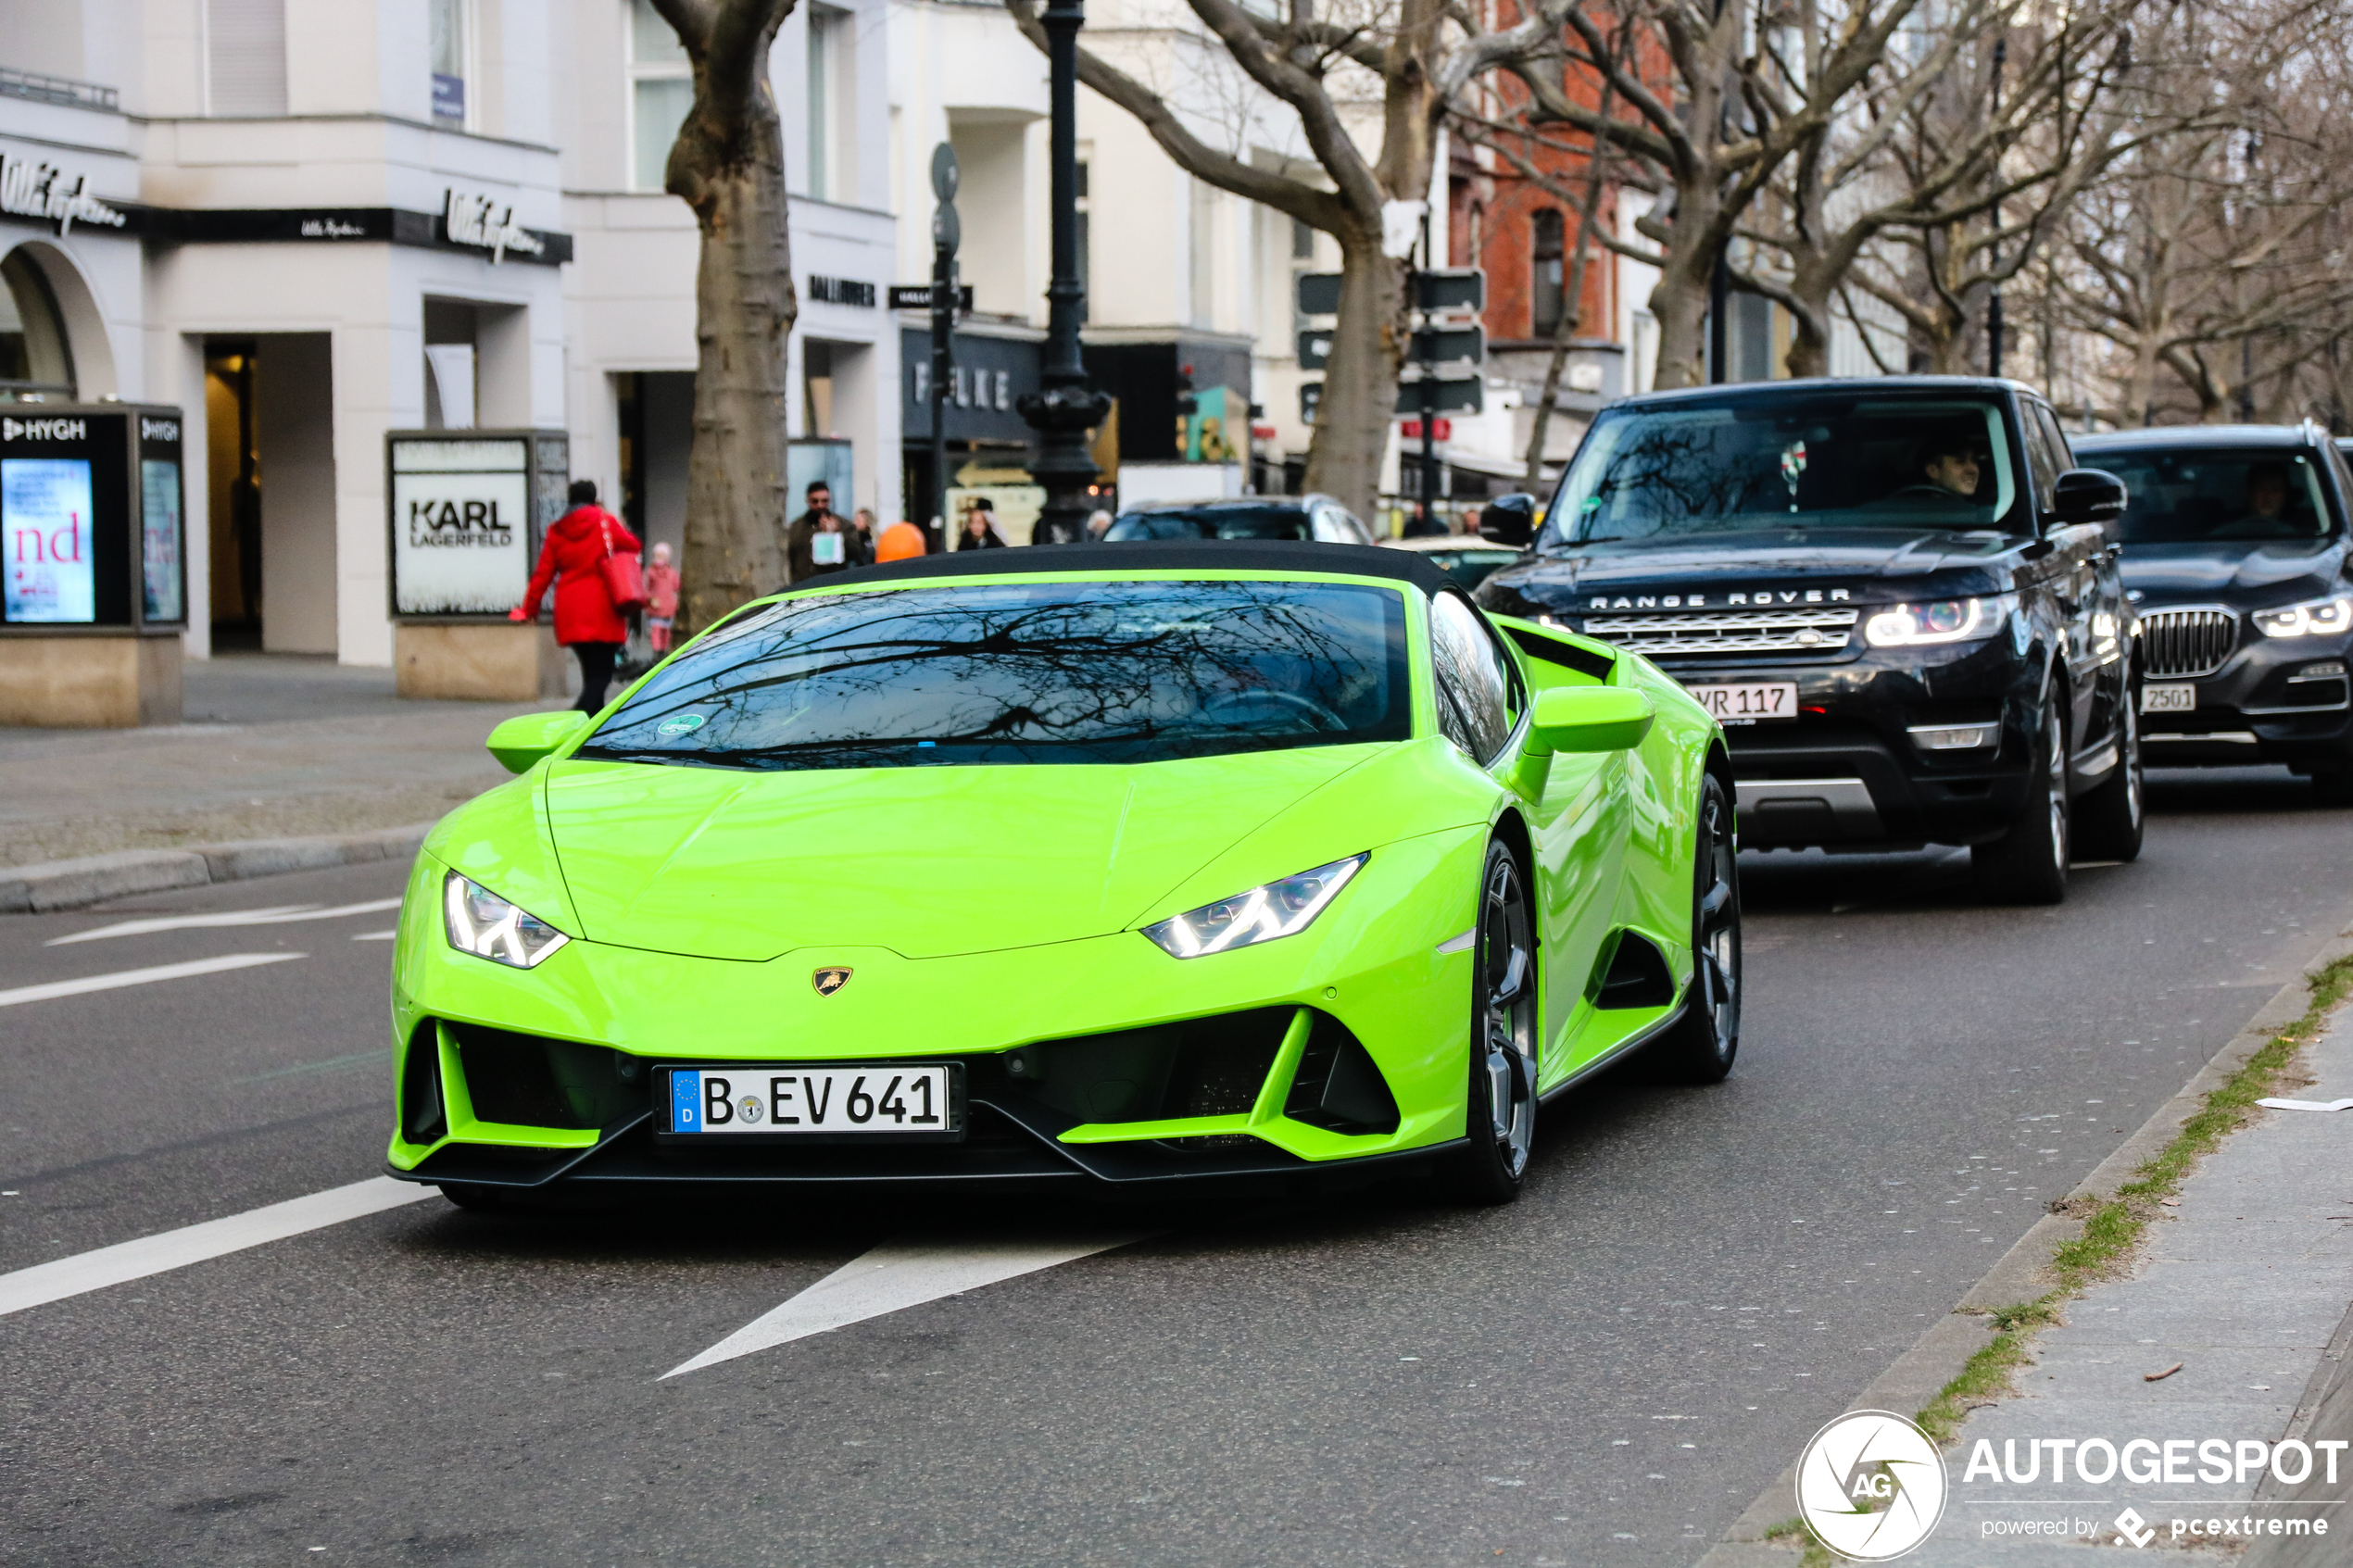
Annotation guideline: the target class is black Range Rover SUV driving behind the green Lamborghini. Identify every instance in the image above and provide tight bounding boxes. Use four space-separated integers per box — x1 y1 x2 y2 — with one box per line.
1478 376 2141 903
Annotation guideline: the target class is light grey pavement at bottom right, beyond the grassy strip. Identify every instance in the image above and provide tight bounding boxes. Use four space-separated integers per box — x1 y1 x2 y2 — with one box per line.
1892 1009 2353 1568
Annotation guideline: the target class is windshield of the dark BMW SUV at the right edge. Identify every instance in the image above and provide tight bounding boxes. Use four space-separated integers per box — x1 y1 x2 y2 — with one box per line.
2084 446 2330 546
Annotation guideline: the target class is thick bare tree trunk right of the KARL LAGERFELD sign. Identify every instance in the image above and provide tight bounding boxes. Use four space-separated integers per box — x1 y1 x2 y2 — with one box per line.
654 0 800 633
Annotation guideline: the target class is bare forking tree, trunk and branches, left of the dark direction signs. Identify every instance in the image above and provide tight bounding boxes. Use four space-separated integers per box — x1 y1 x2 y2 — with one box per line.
1005 0 1567 512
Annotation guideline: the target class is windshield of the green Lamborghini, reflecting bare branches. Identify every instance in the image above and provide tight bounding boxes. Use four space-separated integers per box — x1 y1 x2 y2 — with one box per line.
579 581 1412 769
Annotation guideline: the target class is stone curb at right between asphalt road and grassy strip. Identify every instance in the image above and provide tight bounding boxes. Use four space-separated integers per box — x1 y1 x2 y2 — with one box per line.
1696 929 2353 1568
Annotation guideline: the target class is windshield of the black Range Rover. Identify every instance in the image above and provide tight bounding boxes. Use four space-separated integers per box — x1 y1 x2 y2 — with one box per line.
1543 393 2017 547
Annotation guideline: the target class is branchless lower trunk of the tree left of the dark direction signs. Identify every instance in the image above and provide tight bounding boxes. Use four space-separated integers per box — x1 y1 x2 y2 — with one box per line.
1306 232 1412 521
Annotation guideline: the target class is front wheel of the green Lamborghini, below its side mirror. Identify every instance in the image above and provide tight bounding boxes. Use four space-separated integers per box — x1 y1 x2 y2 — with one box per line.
1454 844 1537 1204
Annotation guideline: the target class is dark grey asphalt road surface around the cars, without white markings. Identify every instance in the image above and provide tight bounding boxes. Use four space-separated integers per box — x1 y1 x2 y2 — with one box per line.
0 771 2353 1568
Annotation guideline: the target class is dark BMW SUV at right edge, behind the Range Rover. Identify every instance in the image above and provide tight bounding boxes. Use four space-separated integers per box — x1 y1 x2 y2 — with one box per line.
2075 425 2353 807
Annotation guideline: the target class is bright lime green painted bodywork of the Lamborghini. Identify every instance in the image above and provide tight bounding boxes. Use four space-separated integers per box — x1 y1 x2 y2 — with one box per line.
388 571 1720 1171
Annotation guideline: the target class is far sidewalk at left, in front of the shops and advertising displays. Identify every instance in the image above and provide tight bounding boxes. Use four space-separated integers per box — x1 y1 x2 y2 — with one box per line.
0 654 560 868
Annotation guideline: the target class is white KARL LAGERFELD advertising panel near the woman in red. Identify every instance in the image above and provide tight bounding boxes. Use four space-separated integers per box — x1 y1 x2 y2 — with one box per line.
393 435 532 616
